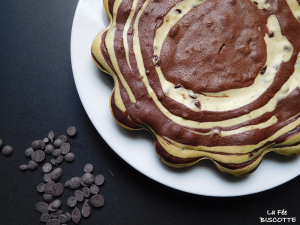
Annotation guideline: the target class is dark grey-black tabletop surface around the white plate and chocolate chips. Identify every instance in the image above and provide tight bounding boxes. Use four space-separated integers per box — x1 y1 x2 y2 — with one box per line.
0 0 300 225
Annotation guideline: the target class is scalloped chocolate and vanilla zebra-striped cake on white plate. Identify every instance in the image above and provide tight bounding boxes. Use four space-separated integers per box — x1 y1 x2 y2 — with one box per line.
91 0 300 176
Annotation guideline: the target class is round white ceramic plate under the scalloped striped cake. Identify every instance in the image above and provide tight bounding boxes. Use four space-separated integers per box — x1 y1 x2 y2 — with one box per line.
71 0 300 196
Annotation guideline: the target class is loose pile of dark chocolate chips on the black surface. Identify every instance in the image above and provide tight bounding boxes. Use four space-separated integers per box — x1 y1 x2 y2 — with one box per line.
19 126 104 225
